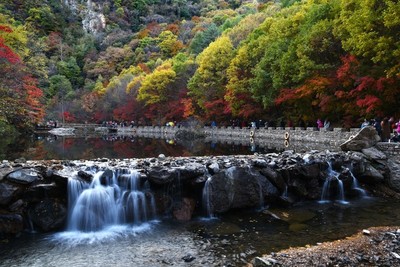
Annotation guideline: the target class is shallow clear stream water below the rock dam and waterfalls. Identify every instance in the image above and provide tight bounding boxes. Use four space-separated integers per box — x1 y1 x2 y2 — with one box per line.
0 198 400 267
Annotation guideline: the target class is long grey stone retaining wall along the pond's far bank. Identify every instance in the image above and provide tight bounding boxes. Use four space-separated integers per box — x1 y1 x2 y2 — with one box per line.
118 126 360 151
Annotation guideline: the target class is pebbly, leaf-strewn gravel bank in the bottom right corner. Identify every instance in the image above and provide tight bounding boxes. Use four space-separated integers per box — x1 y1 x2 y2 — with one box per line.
252 226 400 267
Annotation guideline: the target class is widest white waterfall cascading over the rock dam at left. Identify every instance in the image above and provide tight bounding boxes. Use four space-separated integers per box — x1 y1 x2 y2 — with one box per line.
68 170 155 232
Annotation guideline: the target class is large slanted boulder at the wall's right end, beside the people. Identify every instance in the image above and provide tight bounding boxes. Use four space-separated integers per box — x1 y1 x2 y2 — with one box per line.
340 126 381 151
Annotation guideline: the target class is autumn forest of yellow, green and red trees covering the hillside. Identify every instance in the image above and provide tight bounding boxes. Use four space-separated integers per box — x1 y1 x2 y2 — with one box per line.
0 0 400 132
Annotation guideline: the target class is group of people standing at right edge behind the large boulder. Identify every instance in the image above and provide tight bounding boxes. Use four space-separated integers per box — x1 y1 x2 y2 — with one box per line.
361 117 400 142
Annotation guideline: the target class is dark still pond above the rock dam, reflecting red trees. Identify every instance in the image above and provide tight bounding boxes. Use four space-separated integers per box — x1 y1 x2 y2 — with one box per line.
0 134 278 160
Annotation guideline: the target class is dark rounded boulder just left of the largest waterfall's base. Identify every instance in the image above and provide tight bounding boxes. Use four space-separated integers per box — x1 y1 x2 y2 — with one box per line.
29 199 67 232
